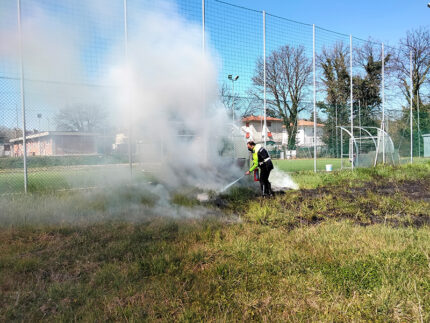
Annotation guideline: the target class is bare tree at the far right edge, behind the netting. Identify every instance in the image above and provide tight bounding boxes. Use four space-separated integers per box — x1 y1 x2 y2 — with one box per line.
394 27 430 109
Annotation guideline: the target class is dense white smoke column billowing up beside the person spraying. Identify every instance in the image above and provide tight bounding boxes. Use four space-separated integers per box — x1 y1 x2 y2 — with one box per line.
107 1 245 189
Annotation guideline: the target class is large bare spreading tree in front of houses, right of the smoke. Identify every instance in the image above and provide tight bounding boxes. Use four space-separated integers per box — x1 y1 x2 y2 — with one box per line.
252 45 312 149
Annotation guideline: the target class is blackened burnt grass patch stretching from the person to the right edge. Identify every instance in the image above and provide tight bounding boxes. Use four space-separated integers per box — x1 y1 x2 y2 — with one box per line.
227 175 430 230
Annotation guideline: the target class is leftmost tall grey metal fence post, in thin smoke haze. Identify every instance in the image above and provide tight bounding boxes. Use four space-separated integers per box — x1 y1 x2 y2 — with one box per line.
17 0 28 193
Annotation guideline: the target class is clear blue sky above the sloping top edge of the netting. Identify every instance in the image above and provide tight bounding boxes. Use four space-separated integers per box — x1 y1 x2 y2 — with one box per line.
228 0 430 45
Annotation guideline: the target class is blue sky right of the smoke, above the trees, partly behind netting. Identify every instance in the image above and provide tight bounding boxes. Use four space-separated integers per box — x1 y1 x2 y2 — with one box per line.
196 0 430 115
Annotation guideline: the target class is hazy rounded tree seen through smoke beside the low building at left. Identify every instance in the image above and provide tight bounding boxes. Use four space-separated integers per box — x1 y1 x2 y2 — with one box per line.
55 104 107 132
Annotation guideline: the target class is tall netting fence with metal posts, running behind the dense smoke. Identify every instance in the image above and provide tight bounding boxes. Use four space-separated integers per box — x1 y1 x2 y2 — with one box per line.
0 0 430 194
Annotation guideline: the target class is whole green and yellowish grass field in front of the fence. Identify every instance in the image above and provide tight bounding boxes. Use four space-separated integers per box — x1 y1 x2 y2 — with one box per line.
0 163 430 322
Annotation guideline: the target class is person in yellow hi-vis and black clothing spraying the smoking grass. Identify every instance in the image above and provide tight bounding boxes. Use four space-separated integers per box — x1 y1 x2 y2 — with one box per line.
245 141 273 197
